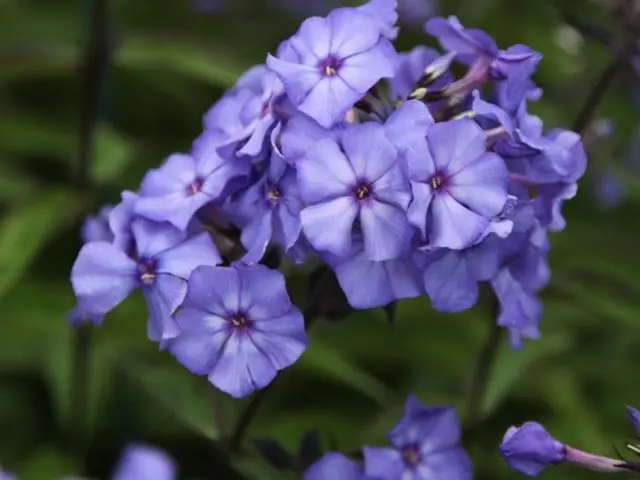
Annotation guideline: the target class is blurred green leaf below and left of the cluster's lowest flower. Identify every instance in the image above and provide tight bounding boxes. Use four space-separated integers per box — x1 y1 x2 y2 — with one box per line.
122 360 221 440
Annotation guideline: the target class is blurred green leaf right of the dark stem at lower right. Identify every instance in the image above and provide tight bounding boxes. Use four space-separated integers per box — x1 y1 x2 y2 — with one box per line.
480 333 571 419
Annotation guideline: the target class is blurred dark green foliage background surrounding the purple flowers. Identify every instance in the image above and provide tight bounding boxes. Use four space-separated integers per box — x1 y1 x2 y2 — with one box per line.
0 0 640 480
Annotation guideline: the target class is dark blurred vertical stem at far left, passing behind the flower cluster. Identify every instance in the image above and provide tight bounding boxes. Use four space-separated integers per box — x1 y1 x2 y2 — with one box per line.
70 0 109 461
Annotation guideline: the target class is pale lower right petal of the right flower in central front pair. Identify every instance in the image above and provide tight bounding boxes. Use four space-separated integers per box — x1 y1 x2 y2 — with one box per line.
429 195 490 250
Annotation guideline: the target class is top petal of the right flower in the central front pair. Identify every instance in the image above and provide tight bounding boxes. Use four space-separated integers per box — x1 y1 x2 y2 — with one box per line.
427 118 486 175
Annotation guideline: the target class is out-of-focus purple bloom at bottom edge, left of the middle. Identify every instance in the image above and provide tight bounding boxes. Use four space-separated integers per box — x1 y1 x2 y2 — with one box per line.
111 444 178 480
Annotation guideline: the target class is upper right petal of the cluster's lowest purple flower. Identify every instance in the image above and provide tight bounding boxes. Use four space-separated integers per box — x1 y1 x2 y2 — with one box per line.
235 265 291 321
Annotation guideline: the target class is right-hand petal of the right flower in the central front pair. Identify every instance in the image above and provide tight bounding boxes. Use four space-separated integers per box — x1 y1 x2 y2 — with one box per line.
447 152 509 217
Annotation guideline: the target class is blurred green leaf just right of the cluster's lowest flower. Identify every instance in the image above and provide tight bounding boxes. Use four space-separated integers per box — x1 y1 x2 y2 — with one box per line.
296 339 395 406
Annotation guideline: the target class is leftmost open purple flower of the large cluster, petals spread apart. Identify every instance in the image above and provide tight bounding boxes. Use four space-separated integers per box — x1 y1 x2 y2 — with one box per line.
71 218 221 341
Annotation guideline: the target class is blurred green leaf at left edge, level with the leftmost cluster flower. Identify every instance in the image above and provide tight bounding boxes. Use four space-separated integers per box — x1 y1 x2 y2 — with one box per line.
0 190 82 298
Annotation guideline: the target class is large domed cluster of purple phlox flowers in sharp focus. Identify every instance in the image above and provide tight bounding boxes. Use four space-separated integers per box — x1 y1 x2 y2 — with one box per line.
70 0 586 404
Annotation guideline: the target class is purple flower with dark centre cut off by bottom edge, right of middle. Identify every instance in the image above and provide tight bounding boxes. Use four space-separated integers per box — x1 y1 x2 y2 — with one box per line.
363 395 472 480
